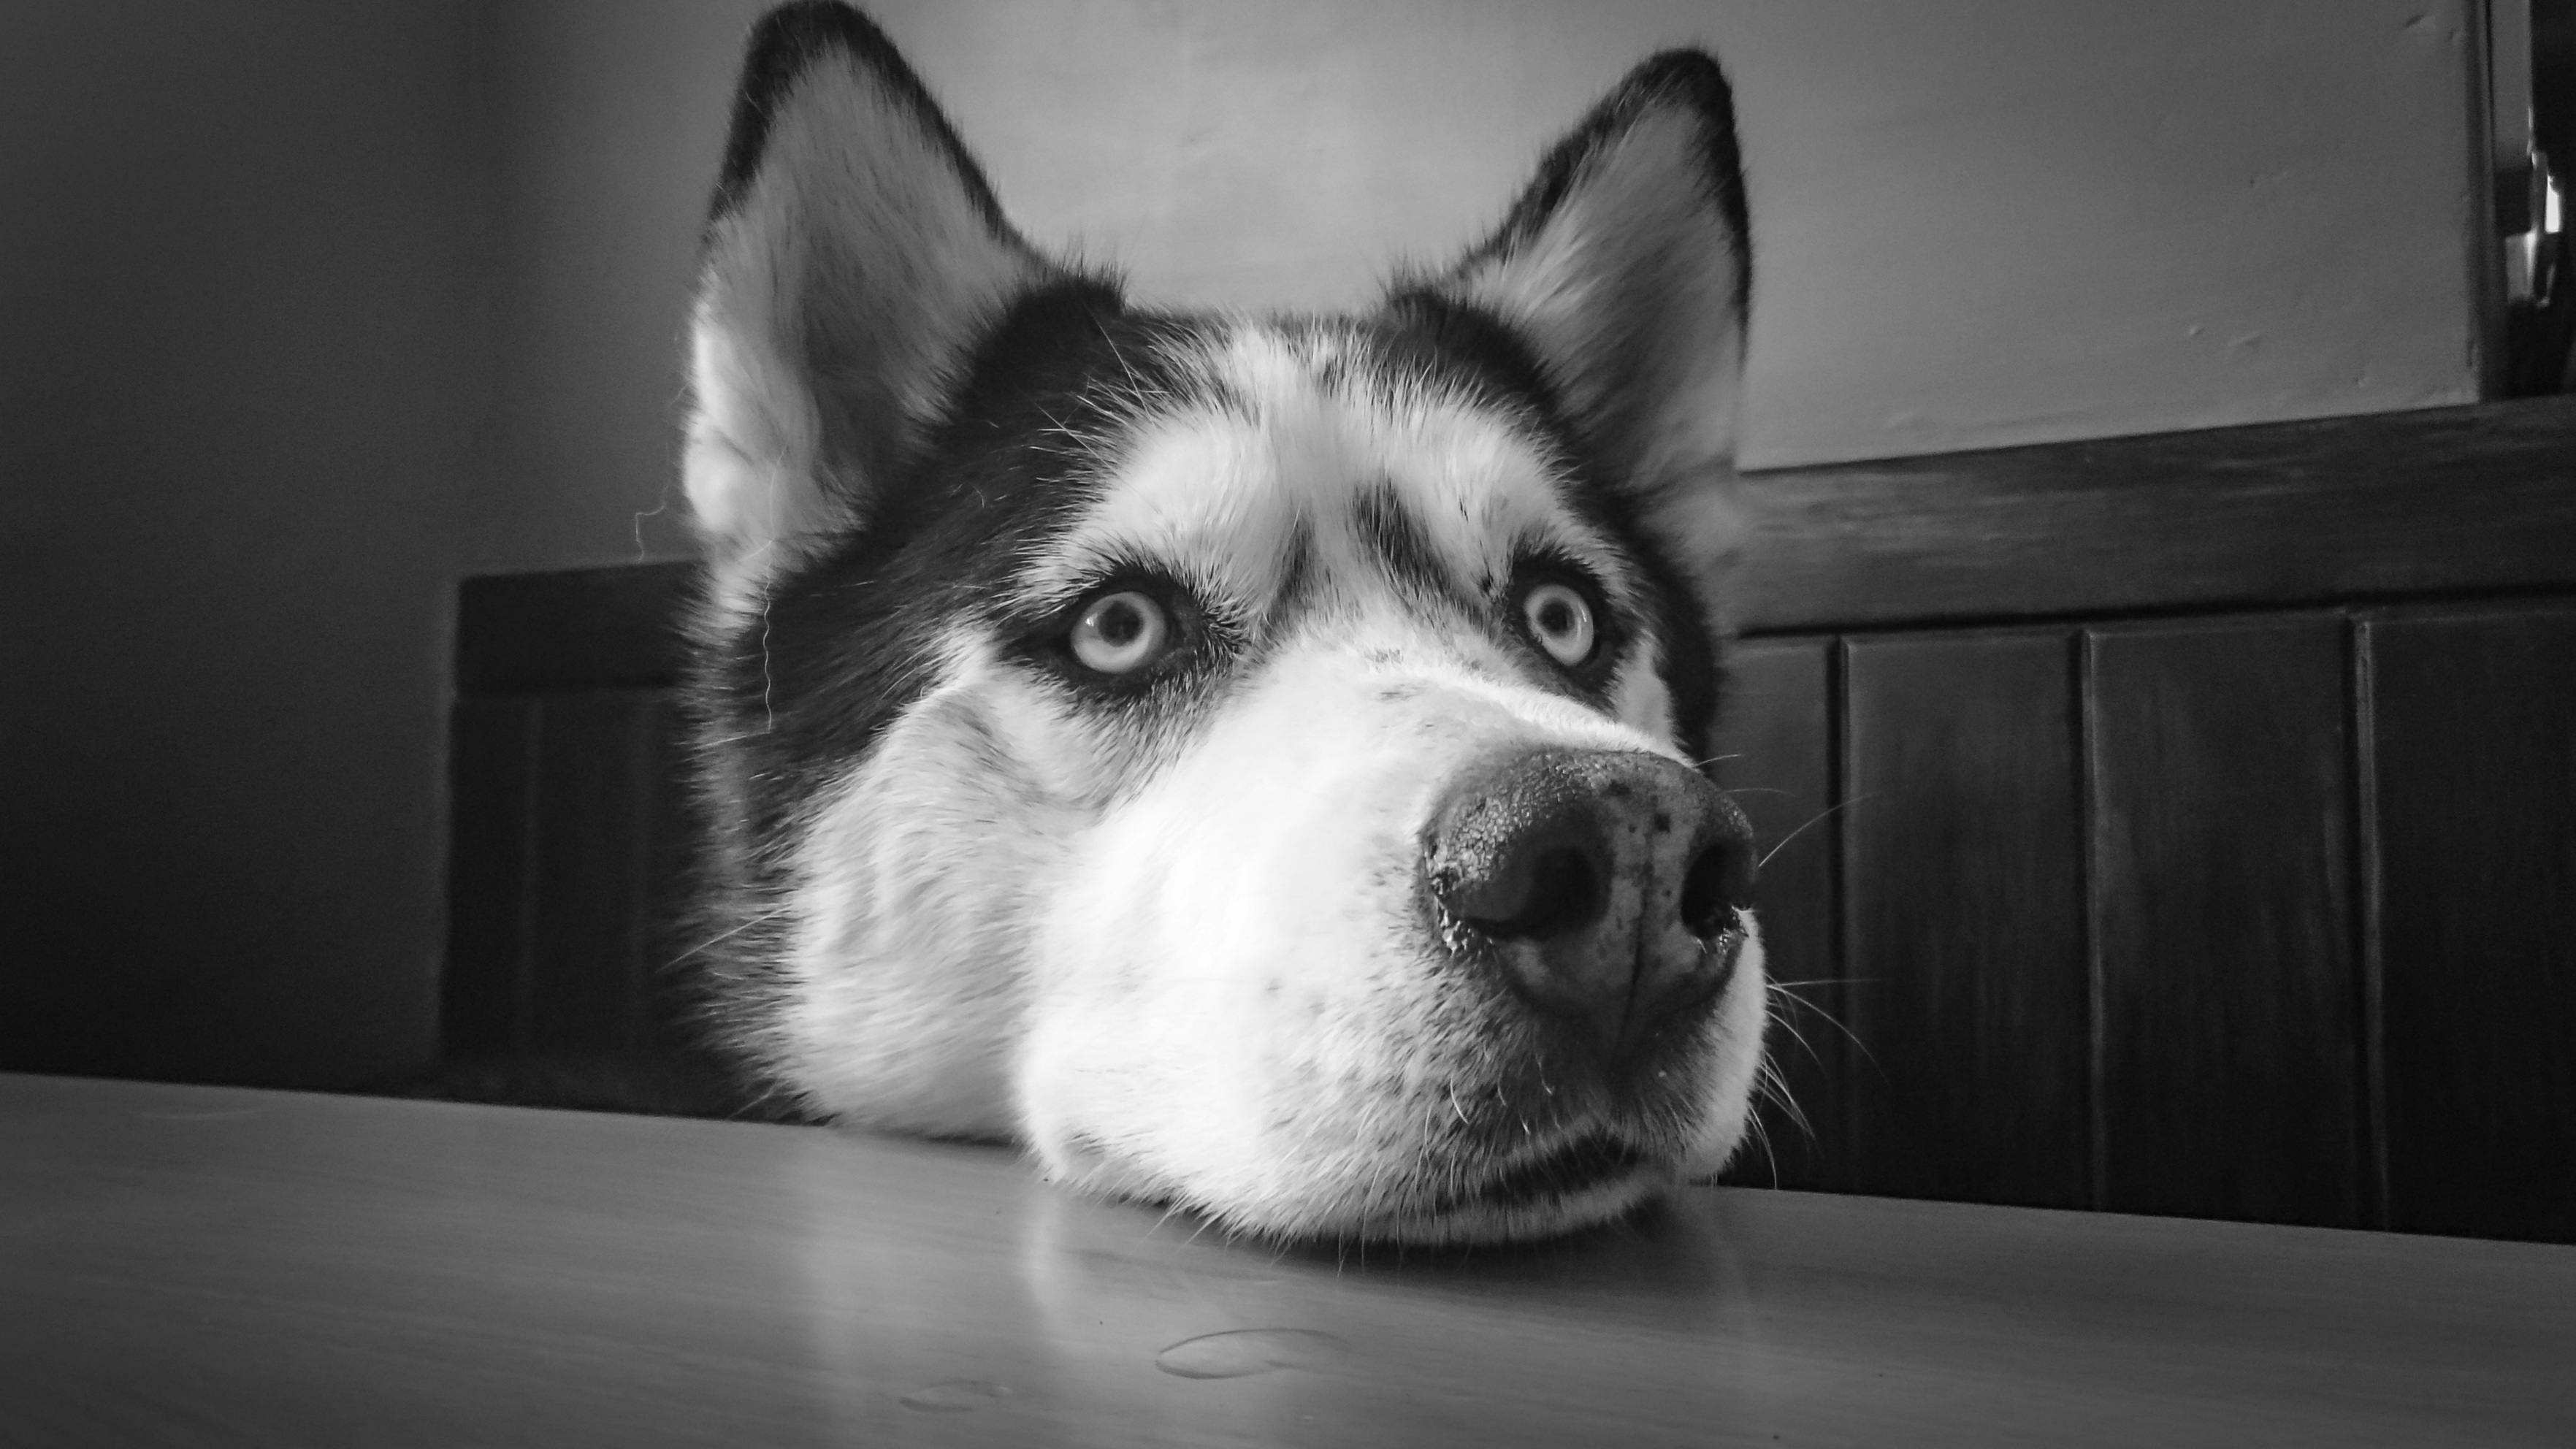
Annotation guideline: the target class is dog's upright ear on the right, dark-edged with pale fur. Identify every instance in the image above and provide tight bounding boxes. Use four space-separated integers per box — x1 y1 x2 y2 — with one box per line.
1396 51 1751 573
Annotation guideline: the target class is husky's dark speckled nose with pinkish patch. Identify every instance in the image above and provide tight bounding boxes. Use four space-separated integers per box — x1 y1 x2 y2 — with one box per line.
1422 749 1754 1058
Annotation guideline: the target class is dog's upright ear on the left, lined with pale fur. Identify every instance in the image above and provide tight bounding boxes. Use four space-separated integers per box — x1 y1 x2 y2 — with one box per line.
683 3 1048 584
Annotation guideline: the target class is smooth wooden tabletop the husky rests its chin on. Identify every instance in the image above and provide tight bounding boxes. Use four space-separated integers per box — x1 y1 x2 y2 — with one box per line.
0 1076 2576 1449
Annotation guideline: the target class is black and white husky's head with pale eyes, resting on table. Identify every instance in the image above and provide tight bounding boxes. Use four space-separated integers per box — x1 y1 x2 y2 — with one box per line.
685 5 1765 1241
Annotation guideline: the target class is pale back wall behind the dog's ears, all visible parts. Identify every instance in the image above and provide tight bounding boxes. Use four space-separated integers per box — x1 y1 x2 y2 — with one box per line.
474 0 2481 586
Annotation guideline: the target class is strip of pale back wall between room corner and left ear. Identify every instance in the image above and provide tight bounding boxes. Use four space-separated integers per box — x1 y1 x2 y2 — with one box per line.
466 0 765 571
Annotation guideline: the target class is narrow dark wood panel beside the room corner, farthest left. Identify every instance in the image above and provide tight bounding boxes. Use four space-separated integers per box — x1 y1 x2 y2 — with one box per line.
438 697 536 1058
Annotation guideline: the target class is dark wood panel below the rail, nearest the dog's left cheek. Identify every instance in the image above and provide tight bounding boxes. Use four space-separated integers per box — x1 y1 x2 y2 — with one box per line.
528 689 657 1052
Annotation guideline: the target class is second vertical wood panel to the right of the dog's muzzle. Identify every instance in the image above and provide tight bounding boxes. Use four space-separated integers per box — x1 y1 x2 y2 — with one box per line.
1842 628 2092 1207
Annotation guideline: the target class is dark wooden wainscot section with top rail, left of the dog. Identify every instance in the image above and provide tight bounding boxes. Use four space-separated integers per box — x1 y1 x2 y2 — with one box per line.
443 564 693 1076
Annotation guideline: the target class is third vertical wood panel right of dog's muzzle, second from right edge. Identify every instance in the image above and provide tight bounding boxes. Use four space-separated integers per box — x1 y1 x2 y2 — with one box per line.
2084 615 2365 1225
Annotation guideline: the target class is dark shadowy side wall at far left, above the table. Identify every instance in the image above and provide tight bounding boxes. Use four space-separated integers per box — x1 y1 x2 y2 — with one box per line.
0 0 487 1084
